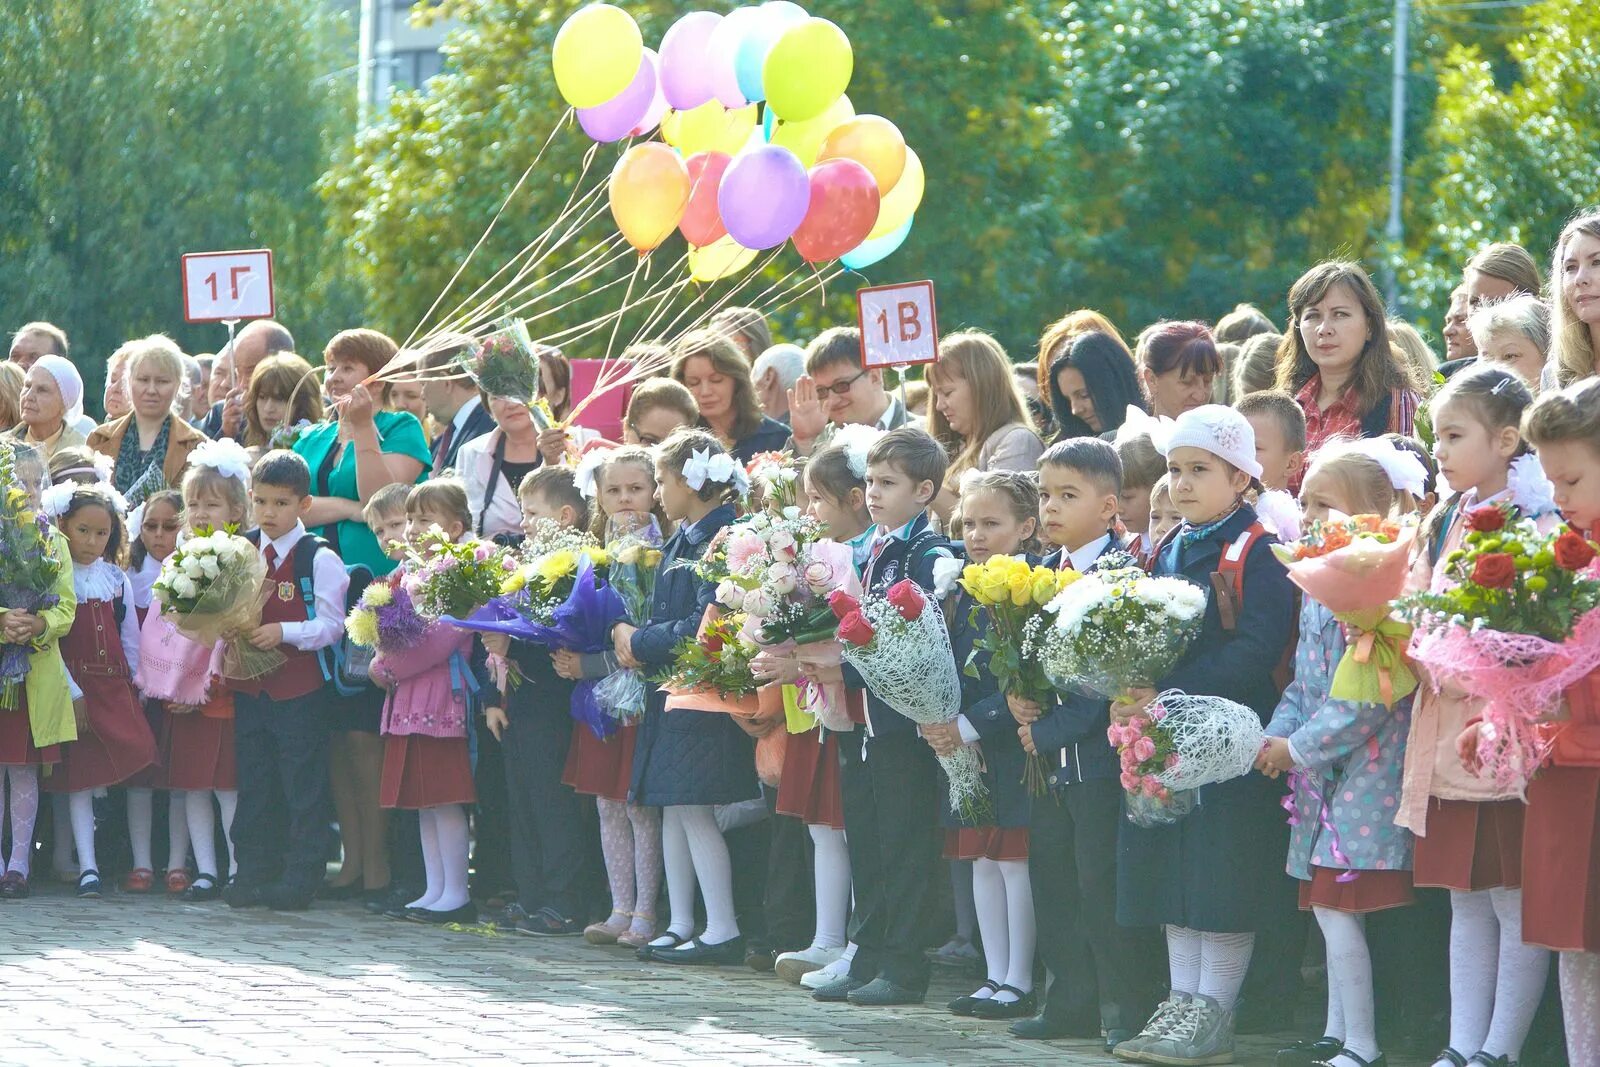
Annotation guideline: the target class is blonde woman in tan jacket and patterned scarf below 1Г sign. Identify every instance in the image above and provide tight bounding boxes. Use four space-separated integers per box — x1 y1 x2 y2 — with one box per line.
88 334 205 504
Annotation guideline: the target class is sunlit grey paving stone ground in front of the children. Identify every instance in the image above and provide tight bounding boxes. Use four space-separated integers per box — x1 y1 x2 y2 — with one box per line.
0 886 1427 1067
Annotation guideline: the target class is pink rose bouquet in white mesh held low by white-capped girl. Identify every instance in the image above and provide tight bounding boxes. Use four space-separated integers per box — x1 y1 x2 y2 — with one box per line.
1106 689 1266 827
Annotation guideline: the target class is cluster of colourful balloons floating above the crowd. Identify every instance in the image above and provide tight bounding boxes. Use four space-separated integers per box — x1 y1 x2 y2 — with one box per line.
552 0 925 282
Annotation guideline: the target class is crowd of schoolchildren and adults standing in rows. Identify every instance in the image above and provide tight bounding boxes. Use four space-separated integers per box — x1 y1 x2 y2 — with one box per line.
0 213 1600 1067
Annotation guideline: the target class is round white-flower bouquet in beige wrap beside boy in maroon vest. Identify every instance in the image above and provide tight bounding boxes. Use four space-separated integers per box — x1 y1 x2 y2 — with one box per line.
152 530 281 681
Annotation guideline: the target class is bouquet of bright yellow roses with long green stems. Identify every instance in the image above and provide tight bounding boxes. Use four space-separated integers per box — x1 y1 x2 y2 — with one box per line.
960 555 1082 797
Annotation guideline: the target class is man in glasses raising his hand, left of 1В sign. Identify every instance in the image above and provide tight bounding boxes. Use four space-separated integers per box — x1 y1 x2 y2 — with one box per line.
786 326 922 456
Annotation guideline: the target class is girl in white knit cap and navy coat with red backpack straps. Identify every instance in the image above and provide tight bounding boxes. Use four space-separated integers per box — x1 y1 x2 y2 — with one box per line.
1112 405 1294 1065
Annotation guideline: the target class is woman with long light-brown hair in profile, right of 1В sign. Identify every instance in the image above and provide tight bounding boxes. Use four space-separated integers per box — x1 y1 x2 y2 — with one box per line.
928 330 1045 522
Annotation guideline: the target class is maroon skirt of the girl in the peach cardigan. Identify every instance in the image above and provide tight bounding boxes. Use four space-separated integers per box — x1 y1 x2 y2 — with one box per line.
1411 797 1528 893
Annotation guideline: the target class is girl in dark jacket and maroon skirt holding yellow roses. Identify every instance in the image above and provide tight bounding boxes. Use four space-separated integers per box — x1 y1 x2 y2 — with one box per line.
922 470 1038 1019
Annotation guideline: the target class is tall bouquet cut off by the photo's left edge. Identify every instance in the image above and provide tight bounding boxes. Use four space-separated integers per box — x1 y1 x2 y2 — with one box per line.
0 438 64 710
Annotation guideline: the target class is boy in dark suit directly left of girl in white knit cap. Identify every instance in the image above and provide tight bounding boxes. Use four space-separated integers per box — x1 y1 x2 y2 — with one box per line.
1008 438 1158 1051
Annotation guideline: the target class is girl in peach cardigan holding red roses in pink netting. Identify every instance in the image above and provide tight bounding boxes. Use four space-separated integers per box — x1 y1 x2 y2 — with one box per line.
1395 366 1558 1067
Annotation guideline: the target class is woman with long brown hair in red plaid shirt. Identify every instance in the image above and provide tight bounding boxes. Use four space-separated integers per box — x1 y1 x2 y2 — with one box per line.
1278 261 1418 479
